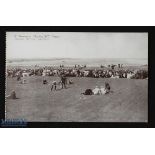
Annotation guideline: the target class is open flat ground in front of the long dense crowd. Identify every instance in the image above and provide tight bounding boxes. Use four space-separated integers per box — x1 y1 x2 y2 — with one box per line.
6 77 148 122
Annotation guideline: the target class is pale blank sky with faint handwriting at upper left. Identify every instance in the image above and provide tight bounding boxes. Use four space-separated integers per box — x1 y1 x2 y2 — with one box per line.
6 32 148 59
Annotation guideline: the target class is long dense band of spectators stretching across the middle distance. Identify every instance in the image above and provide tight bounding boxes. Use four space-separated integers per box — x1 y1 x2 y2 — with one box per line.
6 64 148 80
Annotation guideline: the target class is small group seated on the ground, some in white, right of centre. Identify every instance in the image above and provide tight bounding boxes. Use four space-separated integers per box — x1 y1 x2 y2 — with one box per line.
81 82 111 95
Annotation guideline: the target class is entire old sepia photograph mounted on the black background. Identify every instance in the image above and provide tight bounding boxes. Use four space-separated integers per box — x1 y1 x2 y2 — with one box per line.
5 31 148 123
